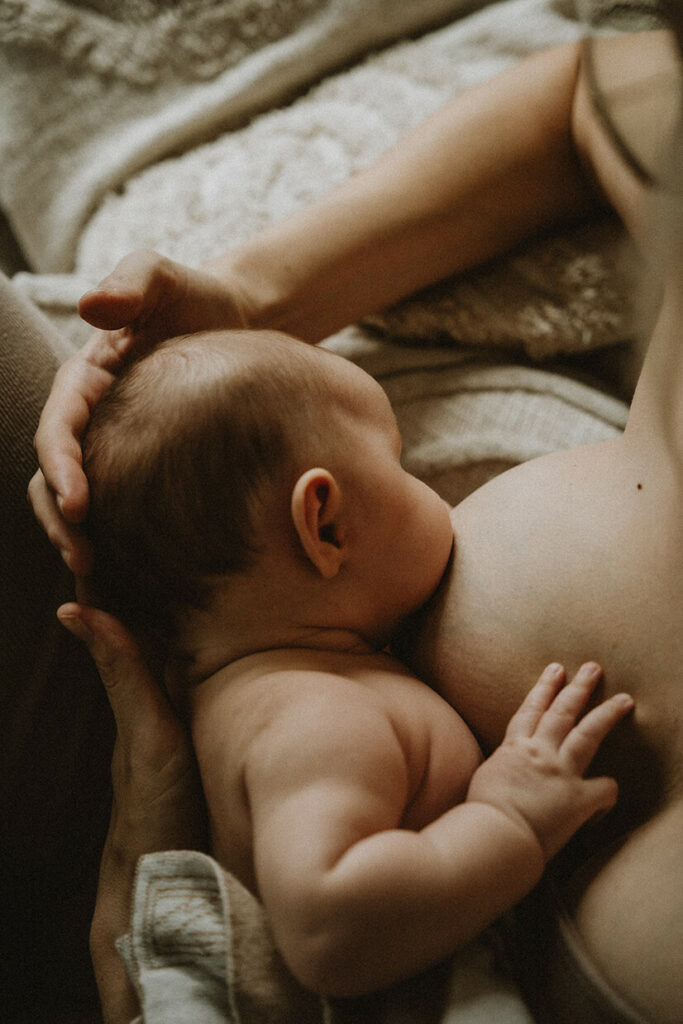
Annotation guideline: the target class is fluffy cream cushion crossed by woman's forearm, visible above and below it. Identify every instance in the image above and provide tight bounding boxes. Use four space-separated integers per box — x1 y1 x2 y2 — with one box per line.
68 0 632 359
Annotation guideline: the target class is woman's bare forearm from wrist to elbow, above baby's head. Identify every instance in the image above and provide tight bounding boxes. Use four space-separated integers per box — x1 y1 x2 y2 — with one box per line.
208 44 596 341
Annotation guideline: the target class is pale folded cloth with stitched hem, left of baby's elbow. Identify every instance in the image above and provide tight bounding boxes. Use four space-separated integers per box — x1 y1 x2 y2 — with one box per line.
119 850 332 1024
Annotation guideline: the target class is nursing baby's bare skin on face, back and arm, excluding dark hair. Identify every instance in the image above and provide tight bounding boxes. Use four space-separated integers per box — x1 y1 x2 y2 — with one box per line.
73 332 633 996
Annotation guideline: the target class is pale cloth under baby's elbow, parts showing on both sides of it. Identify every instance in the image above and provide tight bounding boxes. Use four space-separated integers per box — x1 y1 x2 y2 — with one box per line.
119 850 532 1024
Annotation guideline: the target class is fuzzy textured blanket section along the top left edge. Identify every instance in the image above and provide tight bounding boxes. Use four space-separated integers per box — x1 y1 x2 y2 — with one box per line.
0 0 325 86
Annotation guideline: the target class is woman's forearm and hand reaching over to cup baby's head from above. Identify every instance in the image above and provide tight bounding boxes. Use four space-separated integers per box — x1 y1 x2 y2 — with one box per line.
30 44 630 571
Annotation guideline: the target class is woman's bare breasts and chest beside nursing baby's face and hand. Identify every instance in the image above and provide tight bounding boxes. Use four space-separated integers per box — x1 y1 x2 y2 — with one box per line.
405 430 683 1024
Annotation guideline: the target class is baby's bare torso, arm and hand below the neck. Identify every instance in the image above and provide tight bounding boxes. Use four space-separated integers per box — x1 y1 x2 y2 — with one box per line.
191 648 633 995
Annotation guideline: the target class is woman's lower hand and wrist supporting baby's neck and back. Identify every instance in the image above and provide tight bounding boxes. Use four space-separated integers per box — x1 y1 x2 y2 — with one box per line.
57 603 206 1024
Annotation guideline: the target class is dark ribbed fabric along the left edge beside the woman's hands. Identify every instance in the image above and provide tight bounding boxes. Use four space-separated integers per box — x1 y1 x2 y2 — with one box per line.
0 276 113 1021
